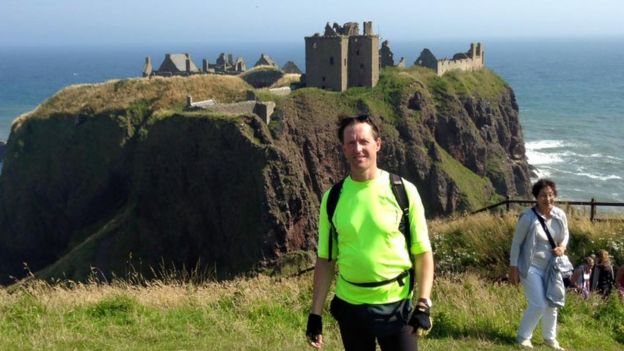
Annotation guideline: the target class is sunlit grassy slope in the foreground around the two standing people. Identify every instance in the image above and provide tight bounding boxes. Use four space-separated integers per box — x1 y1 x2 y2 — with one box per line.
0 215 624 350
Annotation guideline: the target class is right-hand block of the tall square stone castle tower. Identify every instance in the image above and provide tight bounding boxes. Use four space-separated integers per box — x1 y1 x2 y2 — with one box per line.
348 35 379 87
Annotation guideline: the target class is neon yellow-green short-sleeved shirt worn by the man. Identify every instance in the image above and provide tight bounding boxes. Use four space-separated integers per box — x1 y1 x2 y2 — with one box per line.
318 171 431 304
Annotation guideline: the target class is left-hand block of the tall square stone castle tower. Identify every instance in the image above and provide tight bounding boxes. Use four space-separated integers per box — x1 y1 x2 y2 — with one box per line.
305 36 348 91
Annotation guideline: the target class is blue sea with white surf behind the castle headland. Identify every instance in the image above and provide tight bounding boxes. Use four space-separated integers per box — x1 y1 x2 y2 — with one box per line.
0 36 624 210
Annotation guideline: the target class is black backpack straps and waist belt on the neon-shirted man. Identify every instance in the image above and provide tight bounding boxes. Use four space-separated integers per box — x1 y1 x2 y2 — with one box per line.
327 173 414 294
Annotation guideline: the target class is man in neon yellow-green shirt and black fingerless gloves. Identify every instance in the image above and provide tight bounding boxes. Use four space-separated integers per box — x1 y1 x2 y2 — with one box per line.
306 115 433 351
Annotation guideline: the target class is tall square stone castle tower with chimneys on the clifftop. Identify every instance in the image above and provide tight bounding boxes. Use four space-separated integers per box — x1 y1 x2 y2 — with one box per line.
305 22 379 91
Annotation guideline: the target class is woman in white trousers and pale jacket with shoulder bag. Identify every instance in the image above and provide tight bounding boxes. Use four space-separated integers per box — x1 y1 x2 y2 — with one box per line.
509 179 570 350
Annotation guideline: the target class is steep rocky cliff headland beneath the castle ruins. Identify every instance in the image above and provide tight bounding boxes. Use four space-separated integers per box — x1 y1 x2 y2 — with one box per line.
0 69 529 283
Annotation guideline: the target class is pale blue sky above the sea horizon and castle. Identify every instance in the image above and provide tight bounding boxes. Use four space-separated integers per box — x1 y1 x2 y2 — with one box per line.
0 0 624 46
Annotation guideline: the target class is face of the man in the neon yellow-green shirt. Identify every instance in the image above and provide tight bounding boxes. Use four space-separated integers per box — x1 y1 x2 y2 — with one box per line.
342 122 381 172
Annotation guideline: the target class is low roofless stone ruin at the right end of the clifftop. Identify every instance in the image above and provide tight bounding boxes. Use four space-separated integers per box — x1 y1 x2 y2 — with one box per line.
414 43 485 76
